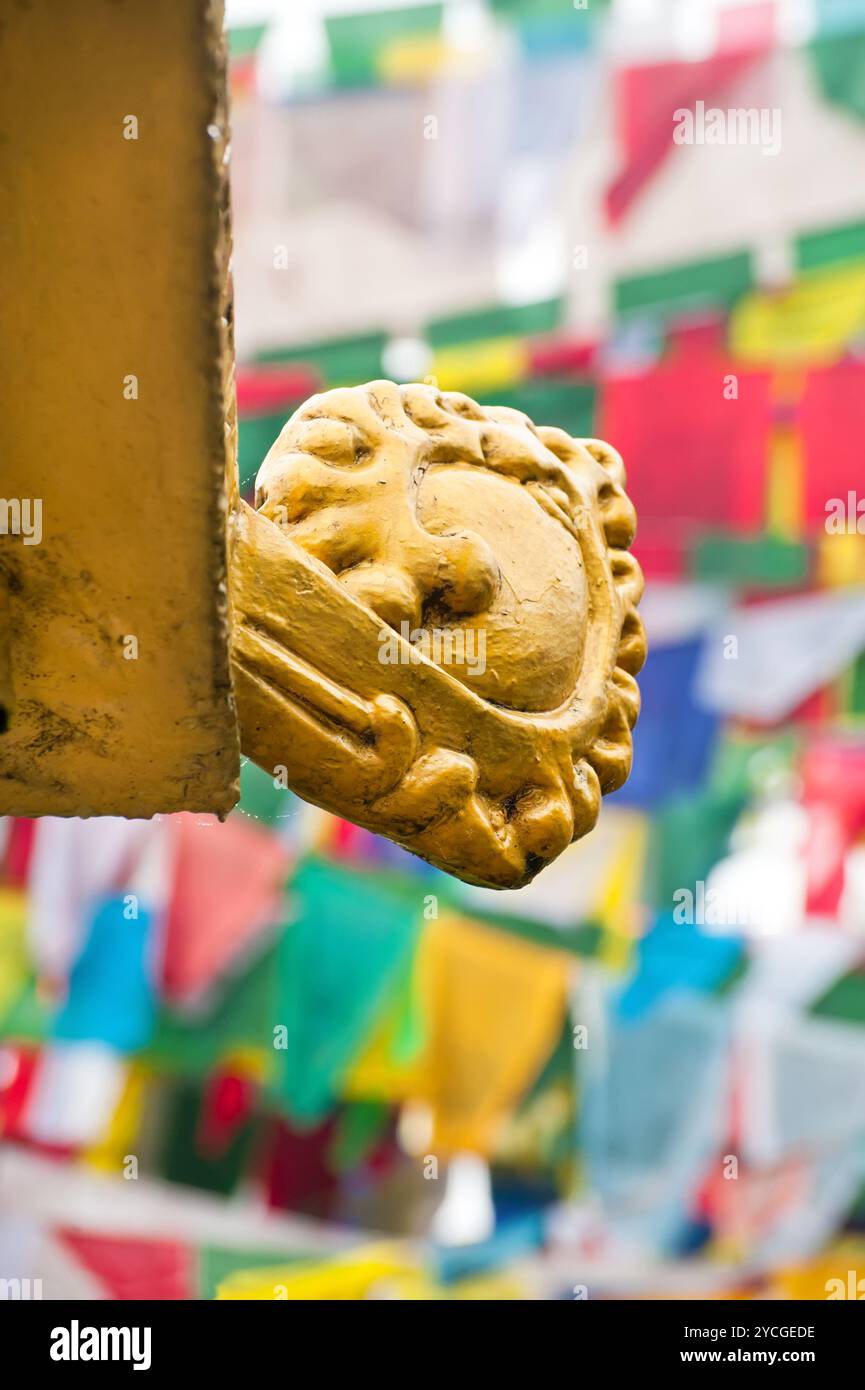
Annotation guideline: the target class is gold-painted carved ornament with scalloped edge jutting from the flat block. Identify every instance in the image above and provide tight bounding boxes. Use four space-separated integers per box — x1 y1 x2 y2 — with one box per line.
231 381 645 888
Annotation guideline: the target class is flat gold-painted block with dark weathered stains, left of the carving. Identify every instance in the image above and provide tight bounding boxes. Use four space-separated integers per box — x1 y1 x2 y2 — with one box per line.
0 0 239 816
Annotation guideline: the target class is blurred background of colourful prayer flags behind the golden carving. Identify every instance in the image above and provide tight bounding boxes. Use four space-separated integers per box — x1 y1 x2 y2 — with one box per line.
0 0 865 1300
